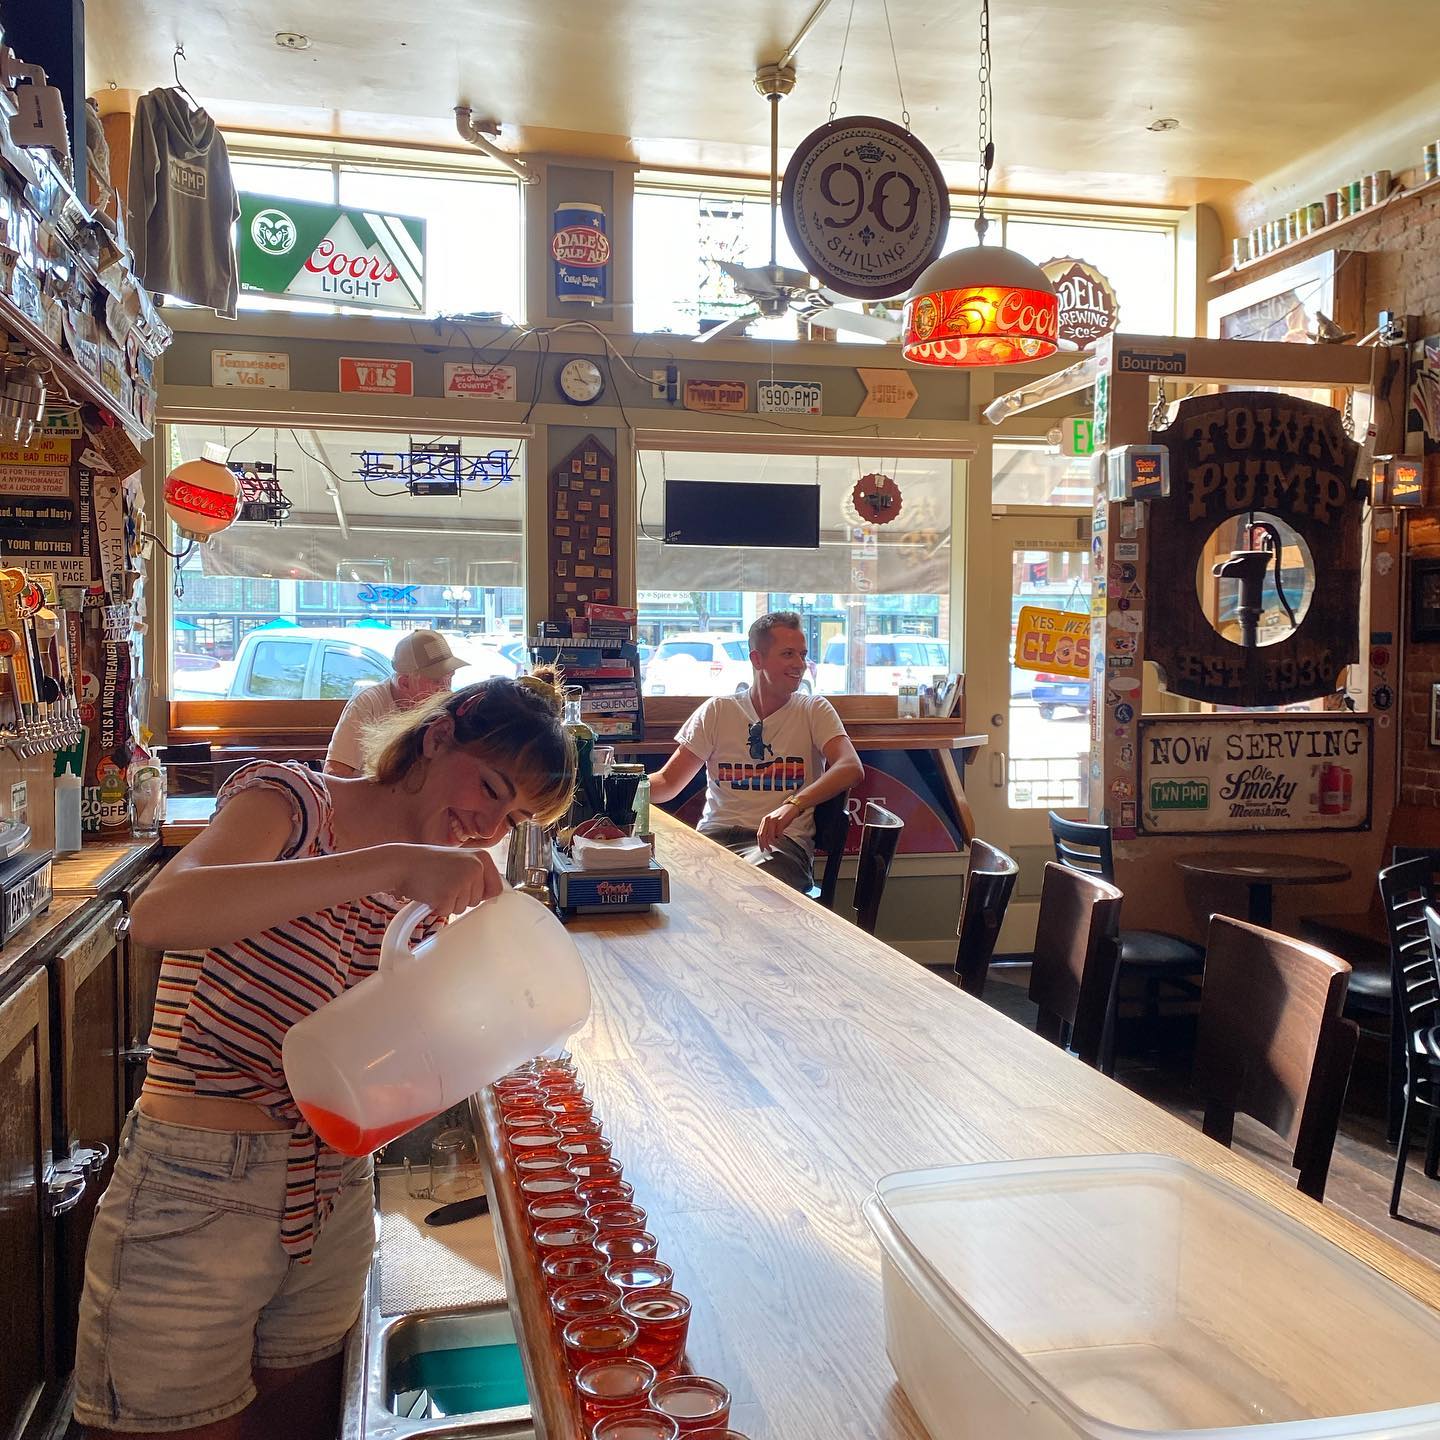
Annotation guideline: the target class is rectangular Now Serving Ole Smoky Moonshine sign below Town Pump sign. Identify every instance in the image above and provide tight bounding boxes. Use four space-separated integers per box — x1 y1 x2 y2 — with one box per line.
1139 714 1371 834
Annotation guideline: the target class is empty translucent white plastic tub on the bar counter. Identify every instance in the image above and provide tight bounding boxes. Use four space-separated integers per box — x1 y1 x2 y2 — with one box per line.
865 1155 1440 1440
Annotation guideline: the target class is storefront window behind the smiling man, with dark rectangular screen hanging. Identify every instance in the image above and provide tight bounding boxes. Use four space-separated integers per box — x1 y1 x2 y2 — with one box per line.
635 451 958 696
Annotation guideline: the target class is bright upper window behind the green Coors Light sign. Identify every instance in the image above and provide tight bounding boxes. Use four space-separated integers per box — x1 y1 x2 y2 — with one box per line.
230 157 521 317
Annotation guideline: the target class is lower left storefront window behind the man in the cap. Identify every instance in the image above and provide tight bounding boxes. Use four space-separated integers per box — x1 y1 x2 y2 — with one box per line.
168 425 524 700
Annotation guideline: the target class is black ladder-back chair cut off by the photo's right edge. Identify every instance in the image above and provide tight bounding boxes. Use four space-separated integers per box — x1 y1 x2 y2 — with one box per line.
1380 855 1440 1215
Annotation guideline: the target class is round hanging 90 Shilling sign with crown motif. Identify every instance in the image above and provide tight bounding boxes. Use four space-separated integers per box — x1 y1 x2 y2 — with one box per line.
780 115 950 300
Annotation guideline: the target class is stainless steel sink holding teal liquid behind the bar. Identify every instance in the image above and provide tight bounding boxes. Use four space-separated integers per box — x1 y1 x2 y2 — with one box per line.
364 1305 534 1440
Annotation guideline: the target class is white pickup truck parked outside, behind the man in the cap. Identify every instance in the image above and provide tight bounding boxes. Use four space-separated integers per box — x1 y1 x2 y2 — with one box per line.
173 625 516 700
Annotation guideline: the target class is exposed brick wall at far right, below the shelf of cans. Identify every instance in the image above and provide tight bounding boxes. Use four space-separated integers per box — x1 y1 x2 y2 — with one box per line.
1225 190 1440 806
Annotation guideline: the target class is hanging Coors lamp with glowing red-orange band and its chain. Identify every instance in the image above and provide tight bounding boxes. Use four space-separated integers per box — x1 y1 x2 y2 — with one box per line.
900 0 1060 366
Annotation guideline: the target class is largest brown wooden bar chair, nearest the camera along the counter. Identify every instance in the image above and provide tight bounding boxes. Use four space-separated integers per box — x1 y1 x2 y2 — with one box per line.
1195 914 1359 1200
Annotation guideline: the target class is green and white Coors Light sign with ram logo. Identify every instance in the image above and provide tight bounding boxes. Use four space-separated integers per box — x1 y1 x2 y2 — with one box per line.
238 194 425 311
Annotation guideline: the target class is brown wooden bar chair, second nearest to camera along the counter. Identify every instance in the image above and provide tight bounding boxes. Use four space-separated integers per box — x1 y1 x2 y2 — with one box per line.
1030 861 1125 1066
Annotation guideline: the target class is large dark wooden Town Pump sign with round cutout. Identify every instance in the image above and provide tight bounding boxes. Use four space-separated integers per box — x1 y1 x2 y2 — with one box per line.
1145 390 1364 707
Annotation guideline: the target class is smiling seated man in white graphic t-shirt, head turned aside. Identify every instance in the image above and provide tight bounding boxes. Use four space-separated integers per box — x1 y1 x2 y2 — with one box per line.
649 611 865 890
